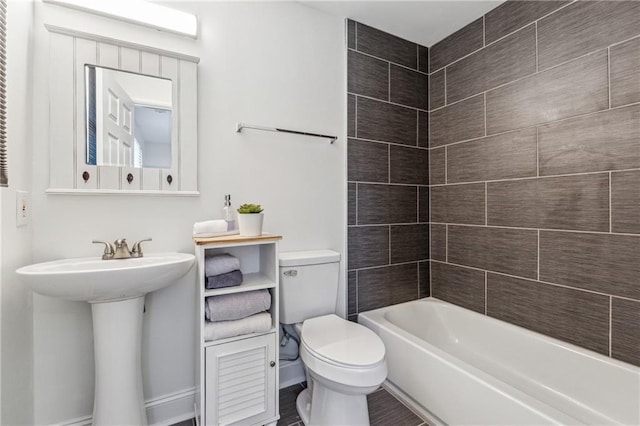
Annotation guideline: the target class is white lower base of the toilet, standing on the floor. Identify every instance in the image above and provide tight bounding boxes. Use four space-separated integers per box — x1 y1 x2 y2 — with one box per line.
296 384 369 426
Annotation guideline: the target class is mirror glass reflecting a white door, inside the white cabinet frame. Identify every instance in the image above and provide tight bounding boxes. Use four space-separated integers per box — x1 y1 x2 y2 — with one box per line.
85 65 173 169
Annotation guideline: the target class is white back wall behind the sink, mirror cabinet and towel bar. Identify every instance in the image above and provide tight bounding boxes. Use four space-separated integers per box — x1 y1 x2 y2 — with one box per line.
23 1 346 424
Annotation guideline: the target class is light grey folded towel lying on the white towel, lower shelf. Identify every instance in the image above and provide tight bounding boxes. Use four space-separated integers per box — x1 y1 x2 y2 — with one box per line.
204 289 271 321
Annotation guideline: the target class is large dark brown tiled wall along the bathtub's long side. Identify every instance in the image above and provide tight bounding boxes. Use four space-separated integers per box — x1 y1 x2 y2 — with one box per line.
429 0 640 365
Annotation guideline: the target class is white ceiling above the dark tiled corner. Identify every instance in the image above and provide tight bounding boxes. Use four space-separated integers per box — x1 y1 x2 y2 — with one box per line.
299 0 504 46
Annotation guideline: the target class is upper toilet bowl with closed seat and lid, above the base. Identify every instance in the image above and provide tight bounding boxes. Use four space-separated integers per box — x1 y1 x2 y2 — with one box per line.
300 314 387 387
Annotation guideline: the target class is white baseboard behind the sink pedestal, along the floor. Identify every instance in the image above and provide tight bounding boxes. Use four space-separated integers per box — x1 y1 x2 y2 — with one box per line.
58 388 196 426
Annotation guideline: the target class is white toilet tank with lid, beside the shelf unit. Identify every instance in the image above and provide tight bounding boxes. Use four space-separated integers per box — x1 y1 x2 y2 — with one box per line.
279 250 340 324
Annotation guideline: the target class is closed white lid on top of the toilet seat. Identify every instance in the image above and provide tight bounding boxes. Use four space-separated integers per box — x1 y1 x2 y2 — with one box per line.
302 314 385 367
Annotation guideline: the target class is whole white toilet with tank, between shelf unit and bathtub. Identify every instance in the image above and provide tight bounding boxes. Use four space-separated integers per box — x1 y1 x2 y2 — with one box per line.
279 250 387 426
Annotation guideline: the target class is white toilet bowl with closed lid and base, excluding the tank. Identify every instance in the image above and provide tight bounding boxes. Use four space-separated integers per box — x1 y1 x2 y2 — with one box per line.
296 314 387 426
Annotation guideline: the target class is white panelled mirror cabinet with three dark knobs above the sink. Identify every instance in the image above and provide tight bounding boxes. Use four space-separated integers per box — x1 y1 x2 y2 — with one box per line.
45 25 199 195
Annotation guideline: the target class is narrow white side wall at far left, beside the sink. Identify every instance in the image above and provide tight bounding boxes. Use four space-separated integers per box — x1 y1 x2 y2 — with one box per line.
0 0 33 425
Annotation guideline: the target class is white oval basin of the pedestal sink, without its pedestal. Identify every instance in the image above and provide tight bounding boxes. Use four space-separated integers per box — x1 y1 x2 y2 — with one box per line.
16 253 195 303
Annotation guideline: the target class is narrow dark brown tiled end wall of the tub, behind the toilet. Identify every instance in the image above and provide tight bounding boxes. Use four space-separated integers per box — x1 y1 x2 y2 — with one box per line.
347 21 430 319
